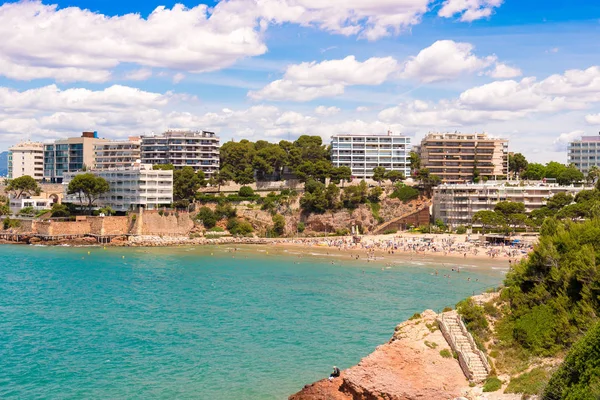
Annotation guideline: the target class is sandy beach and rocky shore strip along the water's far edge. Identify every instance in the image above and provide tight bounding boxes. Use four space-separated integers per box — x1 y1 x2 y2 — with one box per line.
0 233 533 267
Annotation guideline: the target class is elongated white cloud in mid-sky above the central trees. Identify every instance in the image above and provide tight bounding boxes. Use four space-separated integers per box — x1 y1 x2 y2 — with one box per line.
248 56 398 101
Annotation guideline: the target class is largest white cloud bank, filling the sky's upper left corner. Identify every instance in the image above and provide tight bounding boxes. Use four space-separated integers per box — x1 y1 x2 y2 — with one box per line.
0 1 267 82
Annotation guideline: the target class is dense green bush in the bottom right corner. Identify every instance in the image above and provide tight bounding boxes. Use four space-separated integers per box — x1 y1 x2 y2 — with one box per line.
542 323 600 400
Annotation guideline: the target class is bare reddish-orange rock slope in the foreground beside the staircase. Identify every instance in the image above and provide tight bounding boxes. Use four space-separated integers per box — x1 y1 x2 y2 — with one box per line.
290 310 469 400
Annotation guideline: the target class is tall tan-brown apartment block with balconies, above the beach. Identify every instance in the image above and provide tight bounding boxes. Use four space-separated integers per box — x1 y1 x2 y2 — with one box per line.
420 133 508 183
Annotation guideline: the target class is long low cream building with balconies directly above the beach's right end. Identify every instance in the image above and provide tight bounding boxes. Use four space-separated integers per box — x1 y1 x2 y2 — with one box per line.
433 184 585 227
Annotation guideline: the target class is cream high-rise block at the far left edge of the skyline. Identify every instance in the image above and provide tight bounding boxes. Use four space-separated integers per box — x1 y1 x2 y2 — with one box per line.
8 141 44 181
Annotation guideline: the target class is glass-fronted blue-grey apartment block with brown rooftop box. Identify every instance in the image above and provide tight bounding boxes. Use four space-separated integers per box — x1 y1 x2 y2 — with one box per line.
44 132 106 183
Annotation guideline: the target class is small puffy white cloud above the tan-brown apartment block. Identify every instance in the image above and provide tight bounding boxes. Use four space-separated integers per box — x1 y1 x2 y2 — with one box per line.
401 40 496 83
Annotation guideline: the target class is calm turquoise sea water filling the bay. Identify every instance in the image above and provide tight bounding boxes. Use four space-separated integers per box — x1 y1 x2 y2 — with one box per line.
0 246 502 399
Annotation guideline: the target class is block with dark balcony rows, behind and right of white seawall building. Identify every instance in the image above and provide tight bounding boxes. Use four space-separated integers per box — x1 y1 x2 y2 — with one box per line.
141 131 219 179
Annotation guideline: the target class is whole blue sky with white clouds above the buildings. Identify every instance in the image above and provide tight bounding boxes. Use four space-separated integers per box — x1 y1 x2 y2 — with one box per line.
0 0 600 162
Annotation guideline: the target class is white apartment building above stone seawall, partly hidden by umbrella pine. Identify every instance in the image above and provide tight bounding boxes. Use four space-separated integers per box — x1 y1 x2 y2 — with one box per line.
63 164 173 212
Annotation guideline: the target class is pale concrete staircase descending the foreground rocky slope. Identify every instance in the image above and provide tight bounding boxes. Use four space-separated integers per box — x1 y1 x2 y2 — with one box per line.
437 311 491 383
